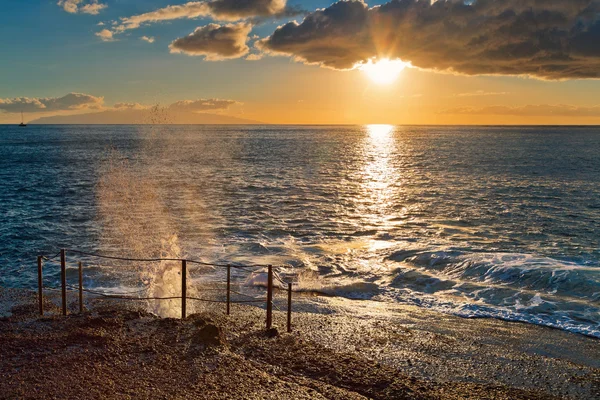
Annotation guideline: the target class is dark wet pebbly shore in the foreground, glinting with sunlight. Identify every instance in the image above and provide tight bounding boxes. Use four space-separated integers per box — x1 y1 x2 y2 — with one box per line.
0 289 600 399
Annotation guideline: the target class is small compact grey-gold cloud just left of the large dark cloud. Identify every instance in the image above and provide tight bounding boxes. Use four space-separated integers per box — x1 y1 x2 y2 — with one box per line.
169 22 252 61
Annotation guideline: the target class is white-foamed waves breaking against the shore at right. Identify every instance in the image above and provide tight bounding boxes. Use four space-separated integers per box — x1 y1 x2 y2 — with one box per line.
298 249 600 338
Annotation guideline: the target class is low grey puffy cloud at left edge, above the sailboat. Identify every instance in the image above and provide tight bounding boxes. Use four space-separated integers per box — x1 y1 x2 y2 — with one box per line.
0 93 104 113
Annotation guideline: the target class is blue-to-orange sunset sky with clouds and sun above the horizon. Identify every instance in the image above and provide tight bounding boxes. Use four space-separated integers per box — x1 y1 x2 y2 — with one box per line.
0 0 600 124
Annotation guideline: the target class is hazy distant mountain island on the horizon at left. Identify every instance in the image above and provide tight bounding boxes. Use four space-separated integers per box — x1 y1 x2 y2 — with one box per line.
28 109 264 125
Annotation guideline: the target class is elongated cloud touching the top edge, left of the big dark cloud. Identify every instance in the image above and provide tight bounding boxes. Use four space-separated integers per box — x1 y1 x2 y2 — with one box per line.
115 0 286 32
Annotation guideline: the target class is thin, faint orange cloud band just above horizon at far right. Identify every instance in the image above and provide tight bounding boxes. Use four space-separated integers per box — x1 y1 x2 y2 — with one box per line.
440 104 600 118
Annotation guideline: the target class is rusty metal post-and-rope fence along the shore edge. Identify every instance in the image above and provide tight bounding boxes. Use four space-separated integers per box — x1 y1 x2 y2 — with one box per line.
37 249 292 332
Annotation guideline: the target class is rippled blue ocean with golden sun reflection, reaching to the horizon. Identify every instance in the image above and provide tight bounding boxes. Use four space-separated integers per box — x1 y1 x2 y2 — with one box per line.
0 125 600 337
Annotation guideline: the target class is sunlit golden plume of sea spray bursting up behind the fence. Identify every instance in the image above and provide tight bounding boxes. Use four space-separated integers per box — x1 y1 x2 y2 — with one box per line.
97 106 216 317
